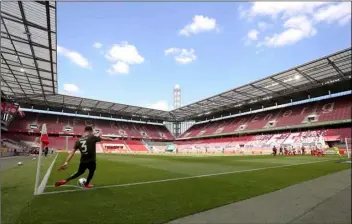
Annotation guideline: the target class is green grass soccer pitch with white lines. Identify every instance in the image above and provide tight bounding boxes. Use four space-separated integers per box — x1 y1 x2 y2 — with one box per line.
1 153 350 224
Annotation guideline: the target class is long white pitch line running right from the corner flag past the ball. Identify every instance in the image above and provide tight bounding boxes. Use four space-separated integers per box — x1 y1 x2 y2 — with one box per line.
43 160 332 194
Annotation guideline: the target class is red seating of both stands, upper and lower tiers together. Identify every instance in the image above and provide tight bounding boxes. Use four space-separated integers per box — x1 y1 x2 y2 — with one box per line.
2 95 351 155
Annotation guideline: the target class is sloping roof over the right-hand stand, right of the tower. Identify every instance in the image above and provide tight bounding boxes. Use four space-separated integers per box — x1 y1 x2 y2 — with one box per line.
172 48 351 120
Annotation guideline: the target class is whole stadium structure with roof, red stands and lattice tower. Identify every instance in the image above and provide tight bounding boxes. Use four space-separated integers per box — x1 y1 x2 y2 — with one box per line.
1 2 351 156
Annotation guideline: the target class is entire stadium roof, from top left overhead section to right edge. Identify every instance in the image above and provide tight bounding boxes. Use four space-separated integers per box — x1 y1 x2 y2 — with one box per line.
1 1 351 121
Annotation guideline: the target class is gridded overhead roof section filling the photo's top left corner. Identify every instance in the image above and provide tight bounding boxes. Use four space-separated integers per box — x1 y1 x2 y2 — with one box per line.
1 1 57 97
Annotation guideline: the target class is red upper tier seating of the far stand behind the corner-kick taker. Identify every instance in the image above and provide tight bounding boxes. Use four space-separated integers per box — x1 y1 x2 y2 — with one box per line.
8 112 174 140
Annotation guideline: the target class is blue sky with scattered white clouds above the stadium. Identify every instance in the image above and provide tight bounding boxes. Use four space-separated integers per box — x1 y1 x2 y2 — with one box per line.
57 2 351 110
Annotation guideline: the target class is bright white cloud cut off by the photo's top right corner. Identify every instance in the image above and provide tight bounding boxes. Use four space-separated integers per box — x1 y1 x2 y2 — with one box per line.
314 2 351 25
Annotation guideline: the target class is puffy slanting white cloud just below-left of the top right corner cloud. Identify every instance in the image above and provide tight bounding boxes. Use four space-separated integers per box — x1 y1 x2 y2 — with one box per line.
262 16 317 47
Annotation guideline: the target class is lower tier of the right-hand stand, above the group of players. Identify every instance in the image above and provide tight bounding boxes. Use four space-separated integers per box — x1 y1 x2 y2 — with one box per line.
175 128 351 154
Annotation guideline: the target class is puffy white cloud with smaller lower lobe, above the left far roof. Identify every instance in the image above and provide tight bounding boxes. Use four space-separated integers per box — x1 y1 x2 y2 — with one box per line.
105 42 144 75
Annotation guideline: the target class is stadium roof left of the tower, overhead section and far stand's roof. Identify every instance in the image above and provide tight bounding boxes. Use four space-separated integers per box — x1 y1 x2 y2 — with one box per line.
1 1 175 120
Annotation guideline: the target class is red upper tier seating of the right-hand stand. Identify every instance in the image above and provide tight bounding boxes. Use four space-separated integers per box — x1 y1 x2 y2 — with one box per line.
179 95 351 138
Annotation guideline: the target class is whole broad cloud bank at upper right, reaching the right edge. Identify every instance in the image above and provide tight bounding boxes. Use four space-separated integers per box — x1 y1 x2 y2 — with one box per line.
239 2 351 47
